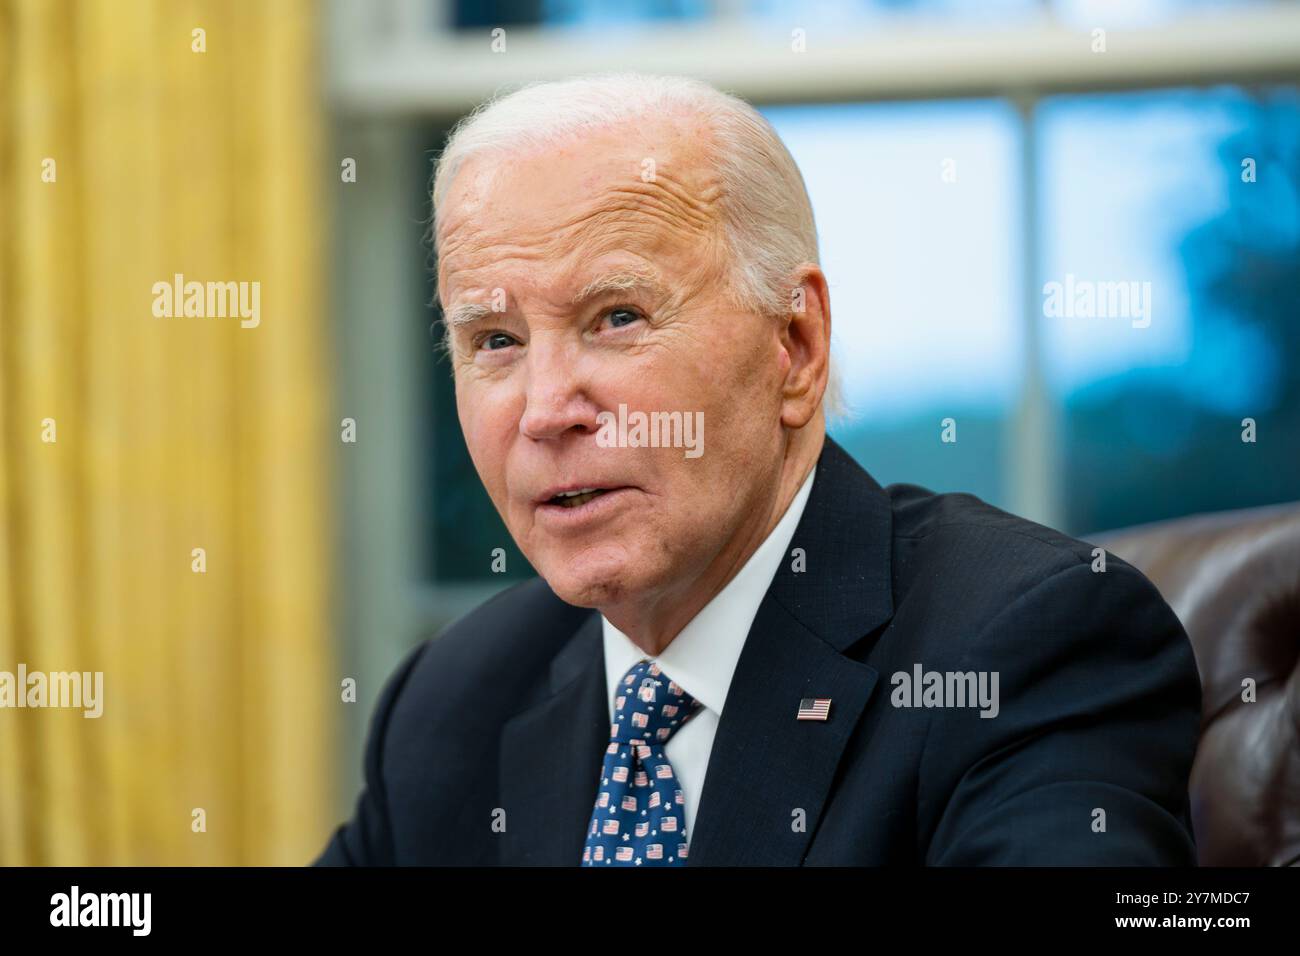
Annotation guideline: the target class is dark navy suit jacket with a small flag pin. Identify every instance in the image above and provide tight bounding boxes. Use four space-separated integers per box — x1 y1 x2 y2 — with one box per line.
316 438 1201 866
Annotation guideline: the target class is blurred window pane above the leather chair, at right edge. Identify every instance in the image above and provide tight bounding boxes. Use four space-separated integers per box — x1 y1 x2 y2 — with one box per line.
1040 87 1300 532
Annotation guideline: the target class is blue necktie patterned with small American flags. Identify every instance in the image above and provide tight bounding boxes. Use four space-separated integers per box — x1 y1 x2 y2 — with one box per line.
582 661 701 866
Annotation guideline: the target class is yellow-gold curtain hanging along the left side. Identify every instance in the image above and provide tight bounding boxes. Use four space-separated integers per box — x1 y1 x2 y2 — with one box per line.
0 0 339 865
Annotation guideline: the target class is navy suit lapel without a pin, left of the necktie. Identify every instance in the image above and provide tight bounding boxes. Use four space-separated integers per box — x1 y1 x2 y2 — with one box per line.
499 613 610 866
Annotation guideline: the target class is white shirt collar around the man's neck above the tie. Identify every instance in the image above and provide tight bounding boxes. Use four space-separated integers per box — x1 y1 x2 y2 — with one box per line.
601 466 816 719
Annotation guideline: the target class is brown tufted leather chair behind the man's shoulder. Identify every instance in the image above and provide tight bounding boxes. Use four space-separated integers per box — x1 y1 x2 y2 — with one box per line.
1088 503 1300 866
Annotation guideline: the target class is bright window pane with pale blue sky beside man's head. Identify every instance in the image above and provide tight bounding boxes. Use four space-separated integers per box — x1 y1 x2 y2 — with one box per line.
763 101 1023 420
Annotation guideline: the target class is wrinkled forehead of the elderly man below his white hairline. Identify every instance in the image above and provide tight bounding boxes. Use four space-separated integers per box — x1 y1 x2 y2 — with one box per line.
438 122 720 293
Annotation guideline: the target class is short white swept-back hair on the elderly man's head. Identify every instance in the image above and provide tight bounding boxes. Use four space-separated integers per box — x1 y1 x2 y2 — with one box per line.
432 73 842 416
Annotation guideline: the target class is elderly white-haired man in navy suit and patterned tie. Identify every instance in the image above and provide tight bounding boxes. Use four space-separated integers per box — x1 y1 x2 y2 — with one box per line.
317 74 1200 866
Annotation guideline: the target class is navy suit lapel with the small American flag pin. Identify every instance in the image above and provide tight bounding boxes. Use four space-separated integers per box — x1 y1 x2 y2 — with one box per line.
689 437 893 866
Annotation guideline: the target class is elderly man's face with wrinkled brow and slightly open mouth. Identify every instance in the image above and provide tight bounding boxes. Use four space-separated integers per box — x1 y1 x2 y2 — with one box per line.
438 121 789 607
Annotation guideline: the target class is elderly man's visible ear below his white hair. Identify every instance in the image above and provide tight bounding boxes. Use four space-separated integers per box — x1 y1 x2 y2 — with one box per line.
780 263 831 428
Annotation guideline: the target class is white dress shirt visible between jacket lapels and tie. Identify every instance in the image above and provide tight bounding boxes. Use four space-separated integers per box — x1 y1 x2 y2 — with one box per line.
601 466 816 840
